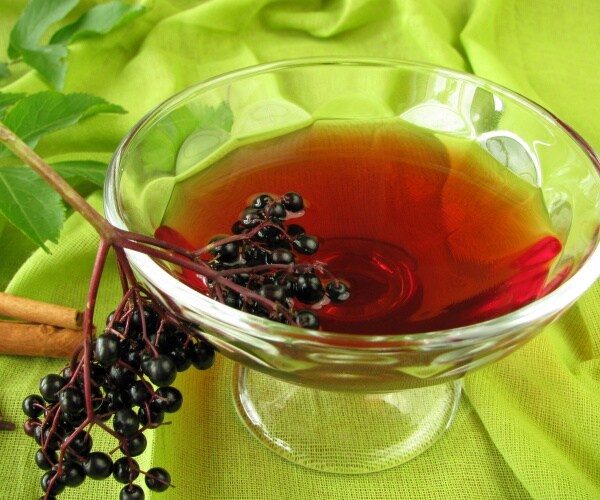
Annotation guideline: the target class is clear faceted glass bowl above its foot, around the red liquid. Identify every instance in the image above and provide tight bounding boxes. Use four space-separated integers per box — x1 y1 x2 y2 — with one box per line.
105 55 600 392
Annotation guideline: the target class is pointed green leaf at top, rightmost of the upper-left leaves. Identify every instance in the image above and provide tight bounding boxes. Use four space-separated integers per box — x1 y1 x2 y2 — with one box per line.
50 0 146 44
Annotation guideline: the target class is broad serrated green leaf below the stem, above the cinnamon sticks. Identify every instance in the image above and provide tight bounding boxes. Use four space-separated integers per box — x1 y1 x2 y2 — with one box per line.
0 167 65 251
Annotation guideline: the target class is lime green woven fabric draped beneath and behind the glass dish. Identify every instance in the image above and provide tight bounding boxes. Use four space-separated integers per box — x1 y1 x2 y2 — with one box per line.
0 0 600 500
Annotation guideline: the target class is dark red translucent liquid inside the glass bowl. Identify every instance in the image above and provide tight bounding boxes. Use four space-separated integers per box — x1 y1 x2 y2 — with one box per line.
158 122 561 334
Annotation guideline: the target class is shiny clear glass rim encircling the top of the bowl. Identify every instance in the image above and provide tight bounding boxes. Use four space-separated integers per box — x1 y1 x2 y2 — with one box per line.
104 56 600 349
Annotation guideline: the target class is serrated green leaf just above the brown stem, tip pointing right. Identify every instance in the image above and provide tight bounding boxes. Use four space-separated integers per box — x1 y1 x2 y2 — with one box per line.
0 90 125 158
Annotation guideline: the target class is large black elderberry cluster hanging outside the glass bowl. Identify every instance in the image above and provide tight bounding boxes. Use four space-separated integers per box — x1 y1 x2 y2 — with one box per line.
22 299 214 500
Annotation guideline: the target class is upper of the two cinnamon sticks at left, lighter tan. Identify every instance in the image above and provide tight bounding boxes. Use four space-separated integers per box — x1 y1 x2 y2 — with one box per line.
0 292 83 330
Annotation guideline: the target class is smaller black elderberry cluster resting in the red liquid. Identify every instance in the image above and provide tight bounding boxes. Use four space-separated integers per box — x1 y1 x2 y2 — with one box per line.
207 192 350 329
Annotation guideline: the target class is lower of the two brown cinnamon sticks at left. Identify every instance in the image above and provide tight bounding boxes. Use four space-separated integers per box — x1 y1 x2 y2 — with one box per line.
0 321 83 358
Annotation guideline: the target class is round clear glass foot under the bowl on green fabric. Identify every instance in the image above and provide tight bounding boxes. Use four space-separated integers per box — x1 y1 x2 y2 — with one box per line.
233 365 461 474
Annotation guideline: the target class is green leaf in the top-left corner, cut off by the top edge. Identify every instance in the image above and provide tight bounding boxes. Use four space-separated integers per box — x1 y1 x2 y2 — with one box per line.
8 0 79 59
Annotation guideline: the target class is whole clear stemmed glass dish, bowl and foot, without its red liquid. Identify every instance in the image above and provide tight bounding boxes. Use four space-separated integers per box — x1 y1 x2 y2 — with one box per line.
105 59 600 474
